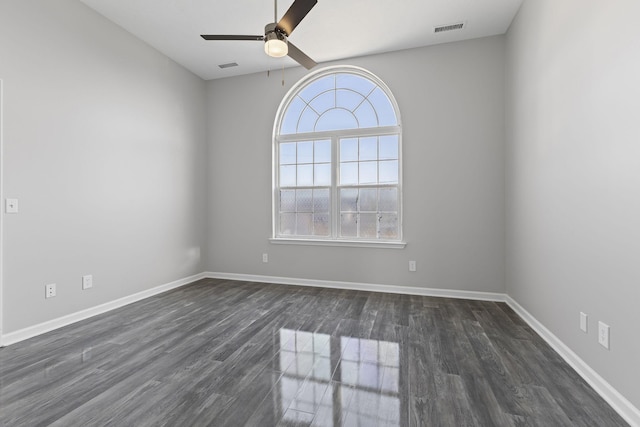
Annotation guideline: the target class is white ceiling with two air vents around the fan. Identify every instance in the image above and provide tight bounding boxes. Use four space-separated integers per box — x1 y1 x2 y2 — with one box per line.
81 0 523 80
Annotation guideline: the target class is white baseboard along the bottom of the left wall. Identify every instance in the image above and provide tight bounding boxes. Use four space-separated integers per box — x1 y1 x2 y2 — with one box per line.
0 273 205 346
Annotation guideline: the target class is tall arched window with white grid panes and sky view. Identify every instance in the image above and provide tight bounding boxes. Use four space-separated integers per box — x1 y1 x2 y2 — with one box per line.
273 66 402 246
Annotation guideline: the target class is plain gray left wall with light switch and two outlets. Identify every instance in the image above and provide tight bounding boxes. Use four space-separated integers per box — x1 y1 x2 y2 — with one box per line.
0 0 207 333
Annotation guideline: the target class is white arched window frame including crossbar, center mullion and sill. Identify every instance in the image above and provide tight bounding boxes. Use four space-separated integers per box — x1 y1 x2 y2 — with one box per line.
269 65 406 249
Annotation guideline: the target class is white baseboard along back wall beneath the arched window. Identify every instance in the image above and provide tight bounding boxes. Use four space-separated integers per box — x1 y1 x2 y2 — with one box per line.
204 272 506 302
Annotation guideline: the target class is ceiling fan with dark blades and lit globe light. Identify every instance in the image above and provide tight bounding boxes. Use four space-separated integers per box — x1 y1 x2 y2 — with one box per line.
201 0 318 70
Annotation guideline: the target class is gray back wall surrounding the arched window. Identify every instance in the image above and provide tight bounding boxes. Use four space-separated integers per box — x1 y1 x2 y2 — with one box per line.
207 36 504 292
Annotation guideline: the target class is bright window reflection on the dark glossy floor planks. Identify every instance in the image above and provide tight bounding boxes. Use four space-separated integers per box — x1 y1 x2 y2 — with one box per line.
274 329 401 426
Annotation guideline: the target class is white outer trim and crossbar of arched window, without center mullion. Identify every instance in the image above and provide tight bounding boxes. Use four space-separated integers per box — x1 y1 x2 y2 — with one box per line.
269 65 407 249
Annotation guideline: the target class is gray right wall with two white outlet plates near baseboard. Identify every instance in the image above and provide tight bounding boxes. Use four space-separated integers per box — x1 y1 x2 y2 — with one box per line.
506 0 640 407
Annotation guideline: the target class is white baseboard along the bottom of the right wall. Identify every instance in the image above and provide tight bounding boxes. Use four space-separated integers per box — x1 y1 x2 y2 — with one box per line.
506 295 640 427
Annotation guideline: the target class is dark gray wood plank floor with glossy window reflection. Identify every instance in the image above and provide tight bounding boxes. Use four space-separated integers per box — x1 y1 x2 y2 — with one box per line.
0 280 626 427
